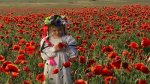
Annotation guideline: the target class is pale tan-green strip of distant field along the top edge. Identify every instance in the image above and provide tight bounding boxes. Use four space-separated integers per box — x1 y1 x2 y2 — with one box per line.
0 0 150 8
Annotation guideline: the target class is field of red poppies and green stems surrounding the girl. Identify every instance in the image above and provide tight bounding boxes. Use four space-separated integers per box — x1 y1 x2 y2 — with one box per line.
0 4 150 84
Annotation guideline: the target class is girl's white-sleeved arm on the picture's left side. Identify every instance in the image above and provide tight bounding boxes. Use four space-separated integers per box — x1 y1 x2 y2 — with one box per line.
40 38 56 60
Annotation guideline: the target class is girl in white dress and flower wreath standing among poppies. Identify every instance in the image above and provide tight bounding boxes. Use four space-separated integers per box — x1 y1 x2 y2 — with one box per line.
40 15 78 84
